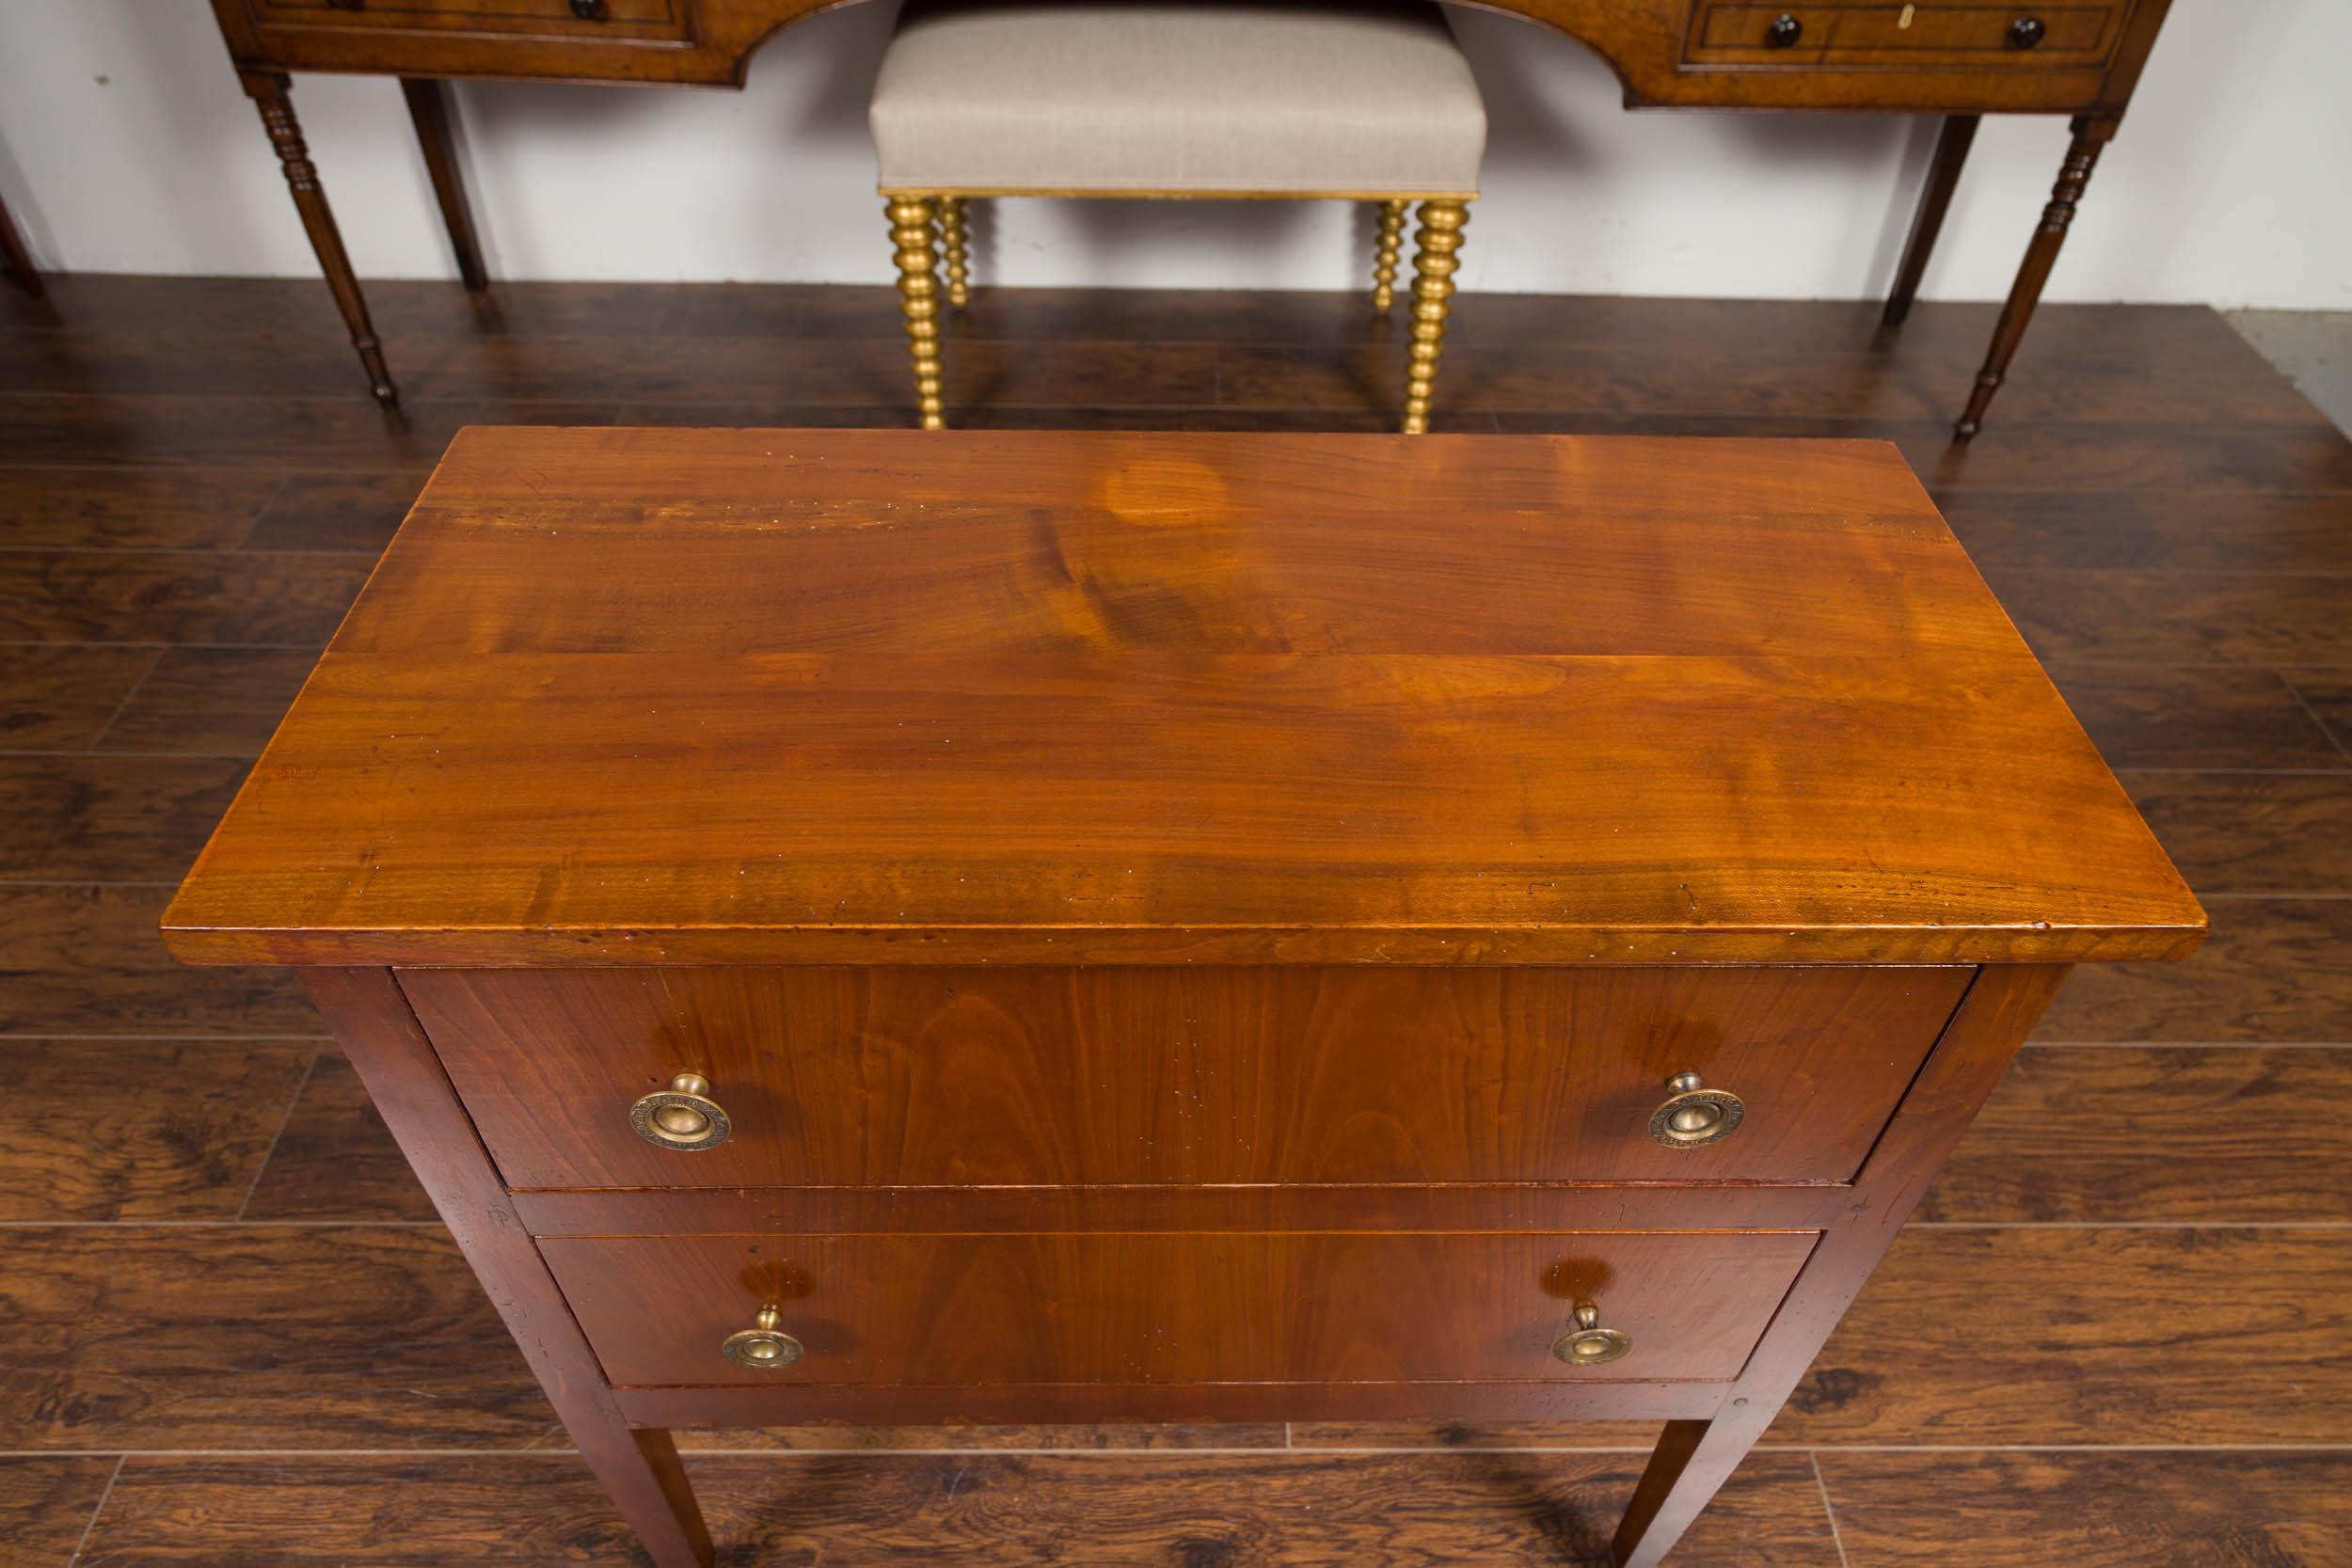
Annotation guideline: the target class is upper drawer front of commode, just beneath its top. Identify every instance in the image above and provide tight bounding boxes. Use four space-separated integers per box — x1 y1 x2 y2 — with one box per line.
400 966 1974 1190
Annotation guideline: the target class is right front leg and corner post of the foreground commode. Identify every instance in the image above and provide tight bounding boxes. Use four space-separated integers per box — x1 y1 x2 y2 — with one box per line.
1612 964 2068 1568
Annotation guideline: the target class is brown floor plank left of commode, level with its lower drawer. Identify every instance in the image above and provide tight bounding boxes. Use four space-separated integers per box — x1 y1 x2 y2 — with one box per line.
0 1225 555 1453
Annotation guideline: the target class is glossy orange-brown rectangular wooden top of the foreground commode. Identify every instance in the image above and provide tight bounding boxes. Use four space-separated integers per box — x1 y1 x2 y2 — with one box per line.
165 430 2204 966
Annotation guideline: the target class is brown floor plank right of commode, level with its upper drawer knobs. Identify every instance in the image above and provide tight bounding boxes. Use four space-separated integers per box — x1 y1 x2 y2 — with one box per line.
1919 1046 2352 1225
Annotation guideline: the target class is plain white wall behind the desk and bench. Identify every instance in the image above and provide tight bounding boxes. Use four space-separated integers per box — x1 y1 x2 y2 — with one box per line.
0 0 2352 308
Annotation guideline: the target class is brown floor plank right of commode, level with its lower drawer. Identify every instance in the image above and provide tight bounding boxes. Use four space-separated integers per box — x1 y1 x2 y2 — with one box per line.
1772 1227 2352 1446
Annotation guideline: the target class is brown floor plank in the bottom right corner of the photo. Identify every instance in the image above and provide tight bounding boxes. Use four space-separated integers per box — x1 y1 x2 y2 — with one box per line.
1820 1450 2352 1568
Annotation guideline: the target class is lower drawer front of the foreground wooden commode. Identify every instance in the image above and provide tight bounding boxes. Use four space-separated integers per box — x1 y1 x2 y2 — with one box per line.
541 1232 1816 1387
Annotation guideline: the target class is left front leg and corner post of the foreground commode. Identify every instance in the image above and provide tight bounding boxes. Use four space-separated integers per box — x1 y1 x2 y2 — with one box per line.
301 969 710 1568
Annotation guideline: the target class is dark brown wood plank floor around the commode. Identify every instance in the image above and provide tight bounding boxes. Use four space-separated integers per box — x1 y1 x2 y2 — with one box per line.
0 277 2352 1568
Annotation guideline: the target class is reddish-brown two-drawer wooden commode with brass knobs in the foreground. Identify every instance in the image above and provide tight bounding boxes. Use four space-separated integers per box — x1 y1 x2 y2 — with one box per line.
165 430 2204 1568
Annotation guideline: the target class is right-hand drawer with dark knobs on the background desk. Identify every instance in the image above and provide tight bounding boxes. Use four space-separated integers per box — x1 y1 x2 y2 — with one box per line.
1687 0 2124 68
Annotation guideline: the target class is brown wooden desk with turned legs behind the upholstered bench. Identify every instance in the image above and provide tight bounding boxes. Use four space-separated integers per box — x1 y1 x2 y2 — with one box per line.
212 0 2171 439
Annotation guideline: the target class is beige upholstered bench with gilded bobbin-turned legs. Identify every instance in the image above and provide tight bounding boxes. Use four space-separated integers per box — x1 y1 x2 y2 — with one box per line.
873 0 1486 433
